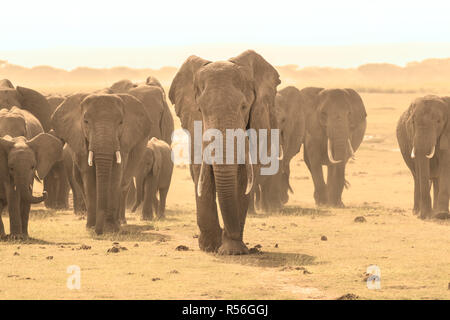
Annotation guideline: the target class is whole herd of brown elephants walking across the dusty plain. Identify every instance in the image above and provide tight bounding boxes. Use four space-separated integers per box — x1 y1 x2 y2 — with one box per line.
0 50 450 254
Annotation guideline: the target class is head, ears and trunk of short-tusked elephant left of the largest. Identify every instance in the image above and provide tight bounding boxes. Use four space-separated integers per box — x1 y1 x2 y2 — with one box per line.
52 94 150 234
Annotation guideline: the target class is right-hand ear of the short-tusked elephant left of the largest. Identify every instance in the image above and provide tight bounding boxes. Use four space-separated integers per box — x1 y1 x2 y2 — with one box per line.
118 94 151 153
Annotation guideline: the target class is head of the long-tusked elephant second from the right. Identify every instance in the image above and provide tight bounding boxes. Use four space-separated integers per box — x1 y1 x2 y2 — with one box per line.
301 88 367 164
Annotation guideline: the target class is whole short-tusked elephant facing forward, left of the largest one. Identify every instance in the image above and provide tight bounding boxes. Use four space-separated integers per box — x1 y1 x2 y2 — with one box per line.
52 94 150 234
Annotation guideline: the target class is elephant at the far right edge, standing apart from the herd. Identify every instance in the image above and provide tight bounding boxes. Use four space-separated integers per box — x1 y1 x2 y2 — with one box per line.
397 96 450 219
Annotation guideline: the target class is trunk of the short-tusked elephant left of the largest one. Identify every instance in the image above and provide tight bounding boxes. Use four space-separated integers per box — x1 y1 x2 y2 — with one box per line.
94 153 113 234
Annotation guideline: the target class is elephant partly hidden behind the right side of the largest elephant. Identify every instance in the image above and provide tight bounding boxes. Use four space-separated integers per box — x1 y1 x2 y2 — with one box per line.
249 86 305 212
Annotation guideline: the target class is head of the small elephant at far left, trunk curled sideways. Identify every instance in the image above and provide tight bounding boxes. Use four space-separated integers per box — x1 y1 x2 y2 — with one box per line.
0 133 63 203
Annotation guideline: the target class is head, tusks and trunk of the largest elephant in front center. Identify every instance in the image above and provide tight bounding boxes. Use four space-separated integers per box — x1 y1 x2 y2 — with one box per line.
169 50 280 248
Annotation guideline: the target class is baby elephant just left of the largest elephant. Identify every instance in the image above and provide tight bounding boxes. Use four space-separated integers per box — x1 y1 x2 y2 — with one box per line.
132 138 173 220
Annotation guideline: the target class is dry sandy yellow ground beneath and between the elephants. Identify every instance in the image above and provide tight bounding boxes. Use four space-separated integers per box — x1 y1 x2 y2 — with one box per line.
0 94 450 299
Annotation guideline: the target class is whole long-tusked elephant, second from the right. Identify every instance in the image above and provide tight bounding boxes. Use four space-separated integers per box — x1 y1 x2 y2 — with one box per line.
300 87 367 207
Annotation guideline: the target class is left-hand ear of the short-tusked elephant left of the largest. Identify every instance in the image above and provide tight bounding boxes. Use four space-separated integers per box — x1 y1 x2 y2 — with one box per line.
51 93 87 154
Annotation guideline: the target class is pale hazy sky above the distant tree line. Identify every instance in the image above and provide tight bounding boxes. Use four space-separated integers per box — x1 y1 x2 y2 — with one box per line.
0 0 450 68
